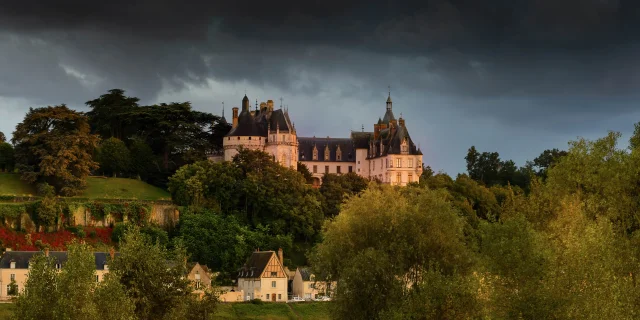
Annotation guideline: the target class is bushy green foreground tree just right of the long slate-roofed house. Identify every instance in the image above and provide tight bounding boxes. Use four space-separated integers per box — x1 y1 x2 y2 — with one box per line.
109 228 191 319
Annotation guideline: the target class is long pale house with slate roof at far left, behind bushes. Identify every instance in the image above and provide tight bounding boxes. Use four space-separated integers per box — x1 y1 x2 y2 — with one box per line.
0 249 117 300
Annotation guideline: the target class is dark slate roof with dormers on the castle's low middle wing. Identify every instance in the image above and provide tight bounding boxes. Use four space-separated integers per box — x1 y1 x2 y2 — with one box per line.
298 137 356 162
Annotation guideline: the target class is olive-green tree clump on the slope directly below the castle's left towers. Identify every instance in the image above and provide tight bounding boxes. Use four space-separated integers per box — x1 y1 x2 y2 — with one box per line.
169 150 323 241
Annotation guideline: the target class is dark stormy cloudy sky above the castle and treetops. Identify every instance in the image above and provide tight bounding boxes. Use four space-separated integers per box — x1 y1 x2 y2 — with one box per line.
0 0 640 174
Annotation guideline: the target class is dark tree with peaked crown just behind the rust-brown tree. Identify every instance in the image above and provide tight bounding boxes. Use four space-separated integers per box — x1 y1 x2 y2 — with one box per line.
86 89 139 140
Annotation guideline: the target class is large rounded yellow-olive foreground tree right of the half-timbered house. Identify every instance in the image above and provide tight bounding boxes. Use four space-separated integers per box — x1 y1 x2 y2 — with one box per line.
312 185 479 319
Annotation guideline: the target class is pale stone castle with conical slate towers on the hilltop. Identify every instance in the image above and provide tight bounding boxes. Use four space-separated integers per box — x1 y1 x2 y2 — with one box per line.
223 93 422 186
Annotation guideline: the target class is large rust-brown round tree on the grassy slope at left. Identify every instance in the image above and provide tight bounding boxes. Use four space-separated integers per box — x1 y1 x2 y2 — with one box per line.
12 105 98 196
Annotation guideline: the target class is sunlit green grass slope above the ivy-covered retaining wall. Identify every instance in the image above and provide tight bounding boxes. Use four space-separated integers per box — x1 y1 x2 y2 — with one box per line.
0 173 171 200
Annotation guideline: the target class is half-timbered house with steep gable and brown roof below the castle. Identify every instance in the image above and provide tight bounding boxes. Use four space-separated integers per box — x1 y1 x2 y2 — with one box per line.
238 249 289 302
